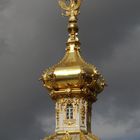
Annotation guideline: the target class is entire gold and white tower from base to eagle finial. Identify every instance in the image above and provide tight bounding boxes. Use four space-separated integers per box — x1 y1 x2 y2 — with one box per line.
41 0 105 140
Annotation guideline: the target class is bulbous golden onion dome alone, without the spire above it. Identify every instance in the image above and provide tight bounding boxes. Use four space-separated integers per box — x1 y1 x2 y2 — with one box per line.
42 46 105 100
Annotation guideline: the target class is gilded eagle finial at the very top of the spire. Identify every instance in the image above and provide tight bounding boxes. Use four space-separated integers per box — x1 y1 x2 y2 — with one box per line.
59 0 82 16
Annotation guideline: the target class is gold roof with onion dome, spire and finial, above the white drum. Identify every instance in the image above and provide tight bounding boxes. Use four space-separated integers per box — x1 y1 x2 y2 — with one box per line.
41 0 105 101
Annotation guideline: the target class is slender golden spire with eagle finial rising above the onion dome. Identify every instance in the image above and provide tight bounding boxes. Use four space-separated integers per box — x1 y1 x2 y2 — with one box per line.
59 0 81 50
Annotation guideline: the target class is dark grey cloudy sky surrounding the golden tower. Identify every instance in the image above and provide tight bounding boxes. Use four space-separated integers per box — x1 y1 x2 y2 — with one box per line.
0 0 140 140
